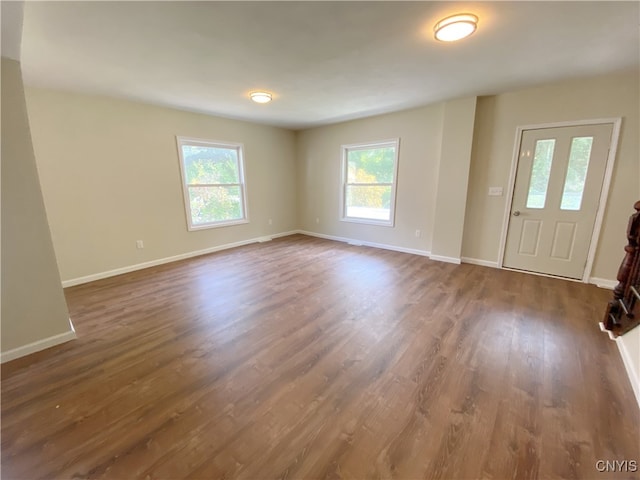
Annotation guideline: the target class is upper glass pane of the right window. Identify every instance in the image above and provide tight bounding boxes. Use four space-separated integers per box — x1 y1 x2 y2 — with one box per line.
347 146 395 183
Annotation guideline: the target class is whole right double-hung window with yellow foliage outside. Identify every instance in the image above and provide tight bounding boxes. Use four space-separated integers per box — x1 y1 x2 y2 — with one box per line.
342 139 399 226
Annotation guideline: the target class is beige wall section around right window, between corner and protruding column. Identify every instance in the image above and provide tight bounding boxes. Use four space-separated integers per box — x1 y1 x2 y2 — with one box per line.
297 104 443 252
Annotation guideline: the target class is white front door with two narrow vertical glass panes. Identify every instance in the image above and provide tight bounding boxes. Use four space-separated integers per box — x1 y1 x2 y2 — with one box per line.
503 124 613 279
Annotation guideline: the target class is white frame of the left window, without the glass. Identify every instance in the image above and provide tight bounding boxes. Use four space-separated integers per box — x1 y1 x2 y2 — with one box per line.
176 137 249 231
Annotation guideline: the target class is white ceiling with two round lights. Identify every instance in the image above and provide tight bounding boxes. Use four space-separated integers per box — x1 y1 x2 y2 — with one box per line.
22 1 640 129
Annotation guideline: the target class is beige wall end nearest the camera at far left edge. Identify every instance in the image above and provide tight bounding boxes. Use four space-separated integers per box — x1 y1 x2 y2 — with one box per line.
1 57 73 354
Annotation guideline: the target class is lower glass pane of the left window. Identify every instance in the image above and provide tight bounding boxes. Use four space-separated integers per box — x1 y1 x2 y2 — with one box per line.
189 186 244 225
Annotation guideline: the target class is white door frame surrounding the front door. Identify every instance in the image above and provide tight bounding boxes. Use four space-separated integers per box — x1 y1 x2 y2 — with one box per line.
498 117 622 283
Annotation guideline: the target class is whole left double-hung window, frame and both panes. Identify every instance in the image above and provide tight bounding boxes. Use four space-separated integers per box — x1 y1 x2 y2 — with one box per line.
178 137 247 230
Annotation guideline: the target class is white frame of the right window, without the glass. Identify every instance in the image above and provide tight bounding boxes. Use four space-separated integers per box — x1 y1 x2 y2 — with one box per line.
340 138 400 227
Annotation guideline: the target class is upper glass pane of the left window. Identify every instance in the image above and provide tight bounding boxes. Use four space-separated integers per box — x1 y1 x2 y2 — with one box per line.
182 145 240 185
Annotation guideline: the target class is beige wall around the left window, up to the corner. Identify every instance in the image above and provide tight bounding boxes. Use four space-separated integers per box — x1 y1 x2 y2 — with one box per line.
26 88 297 280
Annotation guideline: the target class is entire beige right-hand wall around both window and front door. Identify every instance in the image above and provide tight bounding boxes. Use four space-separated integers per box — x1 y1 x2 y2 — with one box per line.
297 72 639 274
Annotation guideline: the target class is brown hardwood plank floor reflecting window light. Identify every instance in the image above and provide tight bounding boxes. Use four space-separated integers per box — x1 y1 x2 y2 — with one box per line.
1 235 640 479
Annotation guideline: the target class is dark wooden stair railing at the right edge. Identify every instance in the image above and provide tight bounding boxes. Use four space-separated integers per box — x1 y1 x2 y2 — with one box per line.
602 201 640 337
